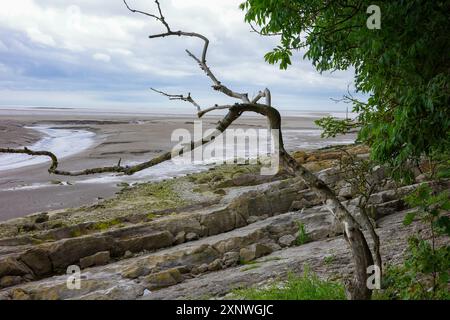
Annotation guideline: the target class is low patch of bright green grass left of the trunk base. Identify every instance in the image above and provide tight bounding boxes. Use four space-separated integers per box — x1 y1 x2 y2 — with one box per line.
234 270 346 300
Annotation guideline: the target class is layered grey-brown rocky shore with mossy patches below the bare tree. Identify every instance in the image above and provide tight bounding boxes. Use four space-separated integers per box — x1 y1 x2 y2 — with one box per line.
0 145 449 299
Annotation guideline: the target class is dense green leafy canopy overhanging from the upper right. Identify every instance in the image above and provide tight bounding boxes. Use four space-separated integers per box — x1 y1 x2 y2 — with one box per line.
241 0 450 172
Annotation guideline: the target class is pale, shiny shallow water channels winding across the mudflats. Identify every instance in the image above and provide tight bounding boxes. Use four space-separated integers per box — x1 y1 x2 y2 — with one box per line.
0 126 354 186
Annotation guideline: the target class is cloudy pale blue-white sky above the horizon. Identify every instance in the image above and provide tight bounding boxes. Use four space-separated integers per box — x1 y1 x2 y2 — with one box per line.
0 0 353 113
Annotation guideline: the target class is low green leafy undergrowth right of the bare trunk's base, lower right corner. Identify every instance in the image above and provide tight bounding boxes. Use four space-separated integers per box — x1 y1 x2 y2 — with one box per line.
378 185 450 299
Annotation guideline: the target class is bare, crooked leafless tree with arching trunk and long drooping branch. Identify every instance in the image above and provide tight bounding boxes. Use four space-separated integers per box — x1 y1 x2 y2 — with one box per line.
0 0 373 299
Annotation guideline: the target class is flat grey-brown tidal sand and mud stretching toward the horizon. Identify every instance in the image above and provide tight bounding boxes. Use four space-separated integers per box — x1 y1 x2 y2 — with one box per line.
0 109 354 220
